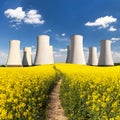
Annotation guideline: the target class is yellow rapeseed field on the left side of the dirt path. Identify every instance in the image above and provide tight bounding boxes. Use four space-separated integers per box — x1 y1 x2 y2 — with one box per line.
0 65 57 120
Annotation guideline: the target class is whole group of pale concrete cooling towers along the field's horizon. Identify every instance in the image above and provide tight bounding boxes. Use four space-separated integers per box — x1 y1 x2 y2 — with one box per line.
6 35 114 67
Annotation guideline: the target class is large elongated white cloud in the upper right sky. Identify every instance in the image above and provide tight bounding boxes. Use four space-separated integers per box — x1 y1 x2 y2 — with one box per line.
85 16 117 28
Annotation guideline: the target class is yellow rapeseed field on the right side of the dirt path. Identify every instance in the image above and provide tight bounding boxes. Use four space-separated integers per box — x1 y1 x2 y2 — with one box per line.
57 64 120 120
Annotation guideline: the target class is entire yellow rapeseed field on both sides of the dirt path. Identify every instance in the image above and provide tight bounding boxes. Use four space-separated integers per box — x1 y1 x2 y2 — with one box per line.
0 64 120 120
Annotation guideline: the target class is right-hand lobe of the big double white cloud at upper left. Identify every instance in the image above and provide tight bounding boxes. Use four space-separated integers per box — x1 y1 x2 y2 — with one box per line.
24 10 45 24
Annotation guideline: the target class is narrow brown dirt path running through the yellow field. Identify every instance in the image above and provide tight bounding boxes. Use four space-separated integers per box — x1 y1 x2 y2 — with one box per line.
47 80 67 120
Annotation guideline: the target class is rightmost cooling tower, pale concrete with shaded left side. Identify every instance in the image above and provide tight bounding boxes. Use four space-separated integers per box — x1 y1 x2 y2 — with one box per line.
98 40 114 66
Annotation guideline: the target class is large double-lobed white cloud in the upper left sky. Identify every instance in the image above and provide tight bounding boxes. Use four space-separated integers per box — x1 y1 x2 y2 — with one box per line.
4 7 45 25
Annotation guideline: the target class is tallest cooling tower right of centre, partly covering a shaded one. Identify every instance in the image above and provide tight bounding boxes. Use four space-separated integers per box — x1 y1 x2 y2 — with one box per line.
71 35 86 64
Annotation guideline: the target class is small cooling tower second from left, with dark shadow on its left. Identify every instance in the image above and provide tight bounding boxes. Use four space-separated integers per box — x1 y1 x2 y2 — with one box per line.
22 47 32 66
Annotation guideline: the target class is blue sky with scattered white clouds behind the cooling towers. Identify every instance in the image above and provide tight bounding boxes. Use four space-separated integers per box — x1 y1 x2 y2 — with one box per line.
0 0 120 64
